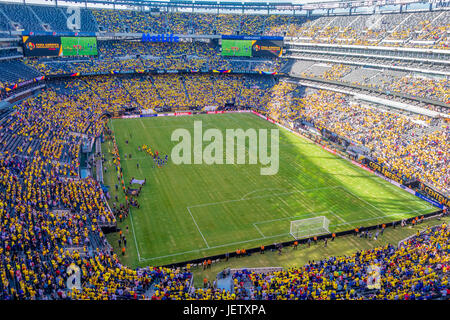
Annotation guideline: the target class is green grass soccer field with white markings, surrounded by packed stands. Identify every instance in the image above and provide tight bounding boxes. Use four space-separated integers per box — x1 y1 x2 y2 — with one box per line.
103 114 434 266
